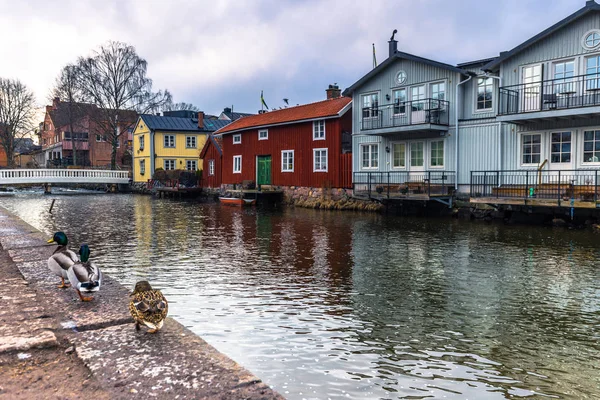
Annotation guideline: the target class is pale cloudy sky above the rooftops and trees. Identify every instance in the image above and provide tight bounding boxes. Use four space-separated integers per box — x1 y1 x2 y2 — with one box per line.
0 0 585 114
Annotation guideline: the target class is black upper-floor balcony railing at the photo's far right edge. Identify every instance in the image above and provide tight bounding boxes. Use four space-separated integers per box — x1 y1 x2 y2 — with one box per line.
498 74 600 115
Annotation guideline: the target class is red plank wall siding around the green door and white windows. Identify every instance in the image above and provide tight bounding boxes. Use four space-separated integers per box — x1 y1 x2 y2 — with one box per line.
223 110 352 188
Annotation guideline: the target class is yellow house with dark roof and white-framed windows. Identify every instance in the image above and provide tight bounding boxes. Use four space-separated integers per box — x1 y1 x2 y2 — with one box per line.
133 111 231 183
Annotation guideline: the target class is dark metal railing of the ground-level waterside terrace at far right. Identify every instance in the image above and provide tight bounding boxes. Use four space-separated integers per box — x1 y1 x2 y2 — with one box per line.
470 169 600 204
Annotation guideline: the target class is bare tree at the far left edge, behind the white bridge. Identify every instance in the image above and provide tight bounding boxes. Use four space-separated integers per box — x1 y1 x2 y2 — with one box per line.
0 78 35 168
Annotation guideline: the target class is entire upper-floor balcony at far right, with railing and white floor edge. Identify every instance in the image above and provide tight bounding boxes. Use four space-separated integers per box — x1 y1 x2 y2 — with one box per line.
498 74 600 122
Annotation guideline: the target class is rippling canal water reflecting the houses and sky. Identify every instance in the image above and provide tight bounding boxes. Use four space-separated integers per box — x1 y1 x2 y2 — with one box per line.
0 193 600 399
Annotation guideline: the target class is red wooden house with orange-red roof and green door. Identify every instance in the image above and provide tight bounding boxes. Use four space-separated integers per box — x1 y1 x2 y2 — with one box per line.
215 91 352 188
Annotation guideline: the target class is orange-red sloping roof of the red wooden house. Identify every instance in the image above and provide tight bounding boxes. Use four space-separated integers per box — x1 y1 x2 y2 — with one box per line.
215 97 352 135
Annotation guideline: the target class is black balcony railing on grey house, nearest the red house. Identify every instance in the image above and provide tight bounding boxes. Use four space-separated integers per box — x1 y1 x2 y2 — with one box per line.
361 99 450 130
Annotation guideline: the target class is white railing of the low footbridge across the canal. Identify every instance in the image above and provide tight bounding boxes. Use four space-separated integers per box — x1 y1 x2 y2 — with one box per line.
0 169 129 185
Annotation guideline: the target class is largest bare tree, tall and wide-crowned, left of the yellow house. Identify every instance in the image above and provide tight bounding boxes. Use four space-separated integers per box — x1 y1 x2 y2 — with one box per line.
77 42 171 169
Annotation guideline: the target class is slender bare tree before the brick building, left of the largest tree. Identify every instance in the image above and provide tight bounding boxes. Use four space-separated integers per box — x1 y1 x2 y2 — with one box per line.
50 64 89 165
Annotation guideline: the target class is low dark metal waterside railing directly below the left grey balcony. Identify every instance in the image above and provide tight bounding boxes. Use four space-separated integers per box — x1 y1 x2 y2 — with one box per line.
352 171 456 199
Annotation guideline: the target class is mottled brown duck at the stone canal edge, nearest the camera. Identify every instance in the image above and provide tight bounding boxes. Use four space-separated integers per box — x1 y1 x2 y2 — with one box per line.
129 281 169 333
